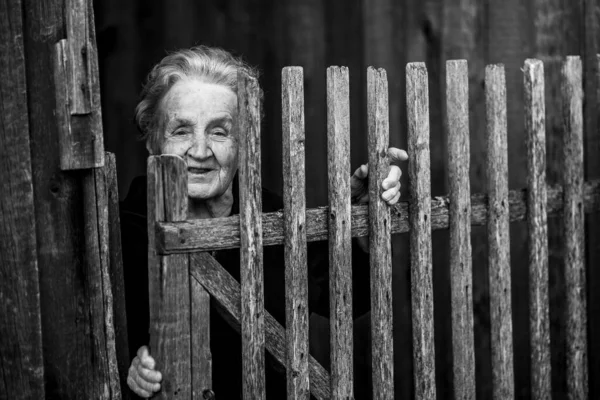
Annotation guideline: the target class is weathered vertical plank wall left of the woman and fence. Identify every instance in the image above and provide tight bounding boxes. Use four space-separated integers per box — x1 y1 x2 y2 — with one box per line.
0 0 129 399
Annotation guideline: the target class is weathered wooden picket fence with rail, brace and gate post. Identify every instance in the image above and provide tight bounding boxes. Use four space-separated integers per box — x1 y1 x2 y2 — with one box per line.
148 57 600 400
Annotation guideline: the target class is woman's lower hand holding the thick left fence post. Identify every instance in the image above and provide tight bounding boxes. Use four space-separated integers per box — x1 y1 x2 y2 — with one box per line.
127 346 162 398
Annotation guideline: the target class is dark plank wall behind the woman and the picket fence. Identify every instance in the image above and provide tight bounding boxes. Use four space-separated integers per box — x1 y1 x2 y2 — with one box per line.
94 0 600 399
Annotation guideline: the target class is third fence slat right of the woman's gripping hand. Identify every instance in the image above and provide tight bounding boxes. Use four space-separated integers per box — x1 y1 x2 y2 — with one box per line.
485 64 514 400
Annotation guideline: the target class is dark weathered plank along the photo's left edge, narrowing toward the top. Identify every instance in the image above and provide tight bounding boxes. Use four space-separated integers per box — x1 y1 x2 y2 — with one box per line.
0 0 45 400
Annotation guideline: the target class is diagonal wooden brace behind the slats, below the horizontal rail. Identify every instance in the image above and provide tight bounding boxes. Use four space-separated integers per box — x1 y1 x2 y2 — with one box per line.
190 253 331 400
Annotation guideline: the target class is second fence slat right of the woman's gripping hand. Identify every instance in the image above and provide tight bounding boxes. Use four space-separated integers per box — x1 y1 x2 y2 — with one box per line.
446 60 475 399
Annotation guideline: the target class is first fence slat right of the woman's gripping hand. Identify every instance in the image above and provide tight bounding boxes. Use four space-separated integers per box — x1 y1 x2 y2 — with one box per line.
406 63 436 400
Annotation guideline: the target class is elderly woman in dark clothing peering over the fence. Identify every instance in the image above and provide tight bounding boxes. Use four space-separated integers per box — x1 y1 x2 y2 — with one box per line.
121 46 407 399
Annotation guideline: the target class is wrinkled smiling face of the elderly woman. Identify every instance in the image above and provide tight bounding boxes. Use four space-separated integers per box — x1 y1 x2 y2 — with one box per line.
158 79 238 200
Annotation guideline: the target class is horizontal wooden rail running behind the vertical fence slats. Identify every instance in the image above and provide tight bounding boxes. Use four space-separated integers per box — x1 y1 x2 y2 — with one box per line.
155 180 600 254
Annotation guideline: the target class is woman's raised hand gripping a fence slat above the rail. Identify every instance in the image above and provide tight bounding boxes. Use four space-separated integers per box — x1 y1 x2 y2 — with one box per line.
350 147 408 253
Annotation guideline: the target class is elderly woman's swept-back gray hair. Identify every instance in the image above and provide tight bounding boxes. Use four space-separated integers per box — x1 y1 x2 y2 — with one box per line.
135 46 258 154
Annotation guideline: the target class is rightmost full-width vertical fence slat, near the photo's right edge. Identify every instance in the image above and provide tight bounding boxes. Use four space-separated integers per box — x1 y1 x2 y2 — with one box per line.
561 56 588 399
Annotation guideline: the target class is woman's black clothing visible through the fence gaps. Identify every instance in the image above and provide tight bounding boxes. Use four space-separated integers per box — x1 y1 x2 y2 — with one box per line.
120 177 370 400
